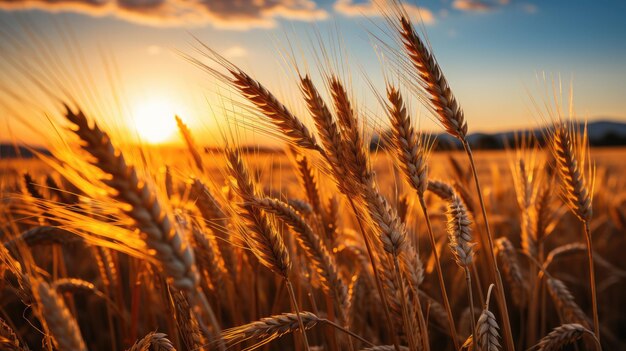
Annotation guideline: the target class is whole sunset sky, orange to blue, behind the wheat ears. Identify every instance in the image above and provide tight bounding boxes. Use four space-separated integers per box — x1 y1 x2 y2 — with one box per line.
0 0 626 146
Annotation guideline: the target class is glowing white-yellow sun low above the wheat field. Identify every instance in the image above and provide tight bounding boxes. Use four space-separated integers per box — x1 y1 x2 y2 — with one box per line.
133 98 183 144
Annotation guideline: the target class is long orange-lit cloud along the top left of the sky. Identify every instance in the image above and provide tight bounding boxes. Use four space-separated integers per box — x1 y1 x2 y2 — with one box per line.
0 0 328 30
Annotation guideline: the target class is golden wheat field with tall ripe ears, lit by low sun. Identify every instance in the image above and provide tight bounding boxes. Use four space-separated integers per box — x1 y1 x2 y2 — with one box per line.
0 1 626 351
